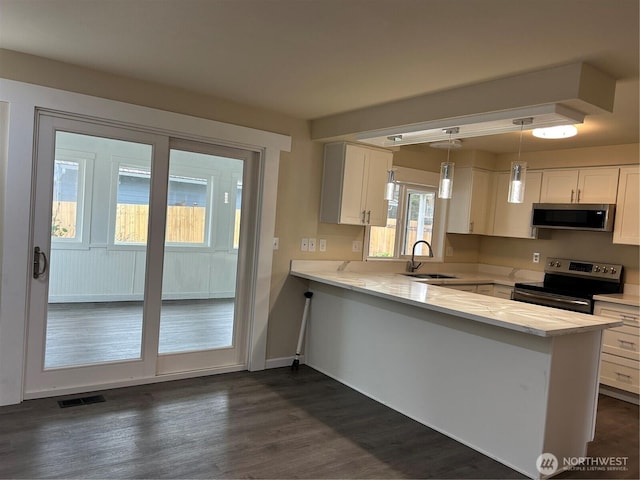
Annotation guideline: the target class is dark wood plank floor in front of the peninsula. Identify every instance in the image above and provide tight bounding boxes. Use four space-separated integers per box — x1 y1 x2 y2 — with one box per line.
0 366 638 478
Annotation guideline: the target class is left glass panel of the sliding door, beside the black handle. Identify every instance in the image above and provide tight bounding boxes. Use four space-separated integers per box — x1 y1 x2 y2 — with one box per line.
44 131 153 369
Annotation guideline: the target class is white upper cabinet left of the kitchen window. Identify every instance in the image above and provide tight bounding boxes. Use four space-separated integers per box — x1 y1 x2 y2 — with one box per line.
320 142 393 226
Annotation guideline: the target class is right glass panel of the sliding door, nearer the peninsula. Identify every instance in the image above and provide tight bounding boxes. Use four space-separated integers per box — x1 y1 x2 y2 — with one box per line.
158 149 244 355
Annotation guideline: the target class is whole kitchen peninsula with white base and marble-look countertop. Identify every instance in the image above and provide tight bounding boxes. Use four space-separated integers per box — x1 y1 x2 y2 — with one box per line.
291 262 620 478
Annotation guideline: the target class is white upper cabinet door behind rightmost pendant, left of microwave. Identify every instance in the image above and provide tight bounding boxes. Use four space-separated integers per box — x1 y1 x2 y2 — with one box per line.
492 172 542 238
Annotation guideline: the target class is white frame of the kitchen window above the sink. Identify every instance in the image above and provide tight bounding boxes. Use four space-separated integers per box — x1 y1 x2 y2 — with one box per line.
365 167 448 263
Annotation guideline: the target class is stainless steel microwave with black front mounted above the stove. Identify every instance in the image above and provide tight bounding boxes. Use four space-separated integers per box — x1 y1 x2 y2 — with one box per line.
531 203 616 232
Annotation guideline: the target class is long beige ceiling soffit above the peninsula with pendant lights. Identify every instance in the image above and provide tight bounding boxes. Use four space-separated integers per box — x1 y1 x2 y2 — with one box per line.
311 63 616 147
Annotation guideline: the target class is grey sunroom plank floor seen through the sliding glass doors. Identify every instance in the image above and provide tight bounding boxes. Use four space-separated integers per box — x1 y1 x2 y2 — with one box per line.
45 299 234 368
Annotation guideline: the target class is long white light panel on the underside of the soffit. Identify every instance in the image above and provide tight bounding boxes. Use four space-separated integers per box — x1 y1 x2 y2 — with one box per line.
355 103 585 147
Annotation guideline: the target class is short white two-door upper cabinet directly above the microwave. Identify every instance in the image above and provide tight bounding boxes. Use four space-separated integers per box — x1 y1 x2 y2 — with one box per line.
540 167 620 203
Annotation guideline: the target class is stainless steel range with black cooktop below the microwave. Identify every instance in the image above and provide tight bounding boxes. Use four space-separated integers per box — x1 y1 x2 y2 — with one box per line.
513 258 622 313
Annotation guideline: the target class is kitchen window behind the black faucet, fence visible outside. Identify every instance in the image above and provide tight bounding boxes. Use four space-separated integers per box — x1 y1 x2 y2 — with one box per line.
367 182 444 258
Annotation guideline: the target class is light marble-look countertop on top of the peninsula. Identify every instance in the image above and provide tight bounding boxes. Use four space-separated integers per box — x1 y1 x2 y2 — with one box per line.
290 263 622 337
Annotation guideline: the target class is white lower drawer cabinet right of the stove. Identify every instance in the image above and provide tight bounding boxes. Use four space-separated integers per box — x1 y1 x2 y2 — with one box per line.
593 301 640 394
